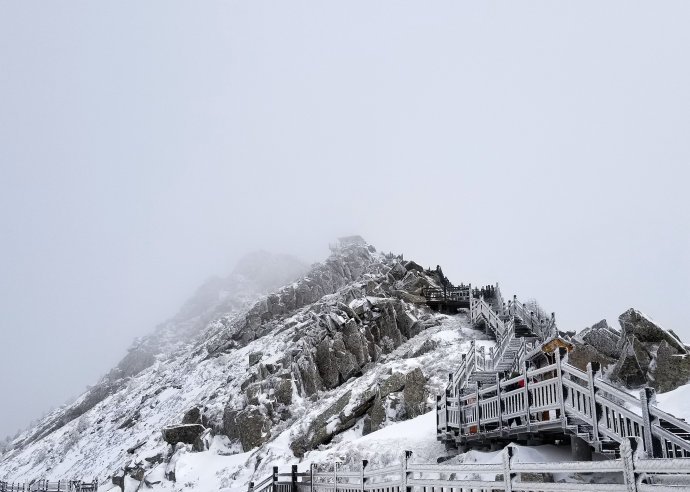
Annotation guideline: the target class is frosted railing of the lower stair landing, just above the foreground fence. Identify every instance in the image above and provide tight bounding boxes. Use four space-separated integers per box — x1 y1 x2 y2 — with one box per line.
437 350 690 458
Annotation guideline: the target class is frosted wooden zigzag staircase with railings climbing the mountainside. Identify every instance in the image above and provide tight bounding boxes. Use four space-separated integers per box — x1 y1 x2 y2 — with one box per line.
437 286 690 458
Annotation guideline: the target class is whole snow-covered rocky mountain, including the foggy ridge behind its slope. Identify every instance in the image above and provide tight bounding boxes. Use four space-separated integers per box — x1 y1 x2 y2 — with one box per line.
0 237 685 492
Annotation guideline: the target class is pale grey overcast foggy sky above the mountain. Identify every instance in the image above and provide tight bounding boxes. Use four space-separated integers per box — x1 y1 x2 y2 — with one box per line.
0 0 690 436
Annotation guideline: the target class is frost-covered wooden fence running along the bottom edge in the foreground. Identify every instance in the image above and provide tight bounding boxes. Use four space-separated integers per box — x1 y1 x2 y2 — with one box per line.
249 438 690 492
